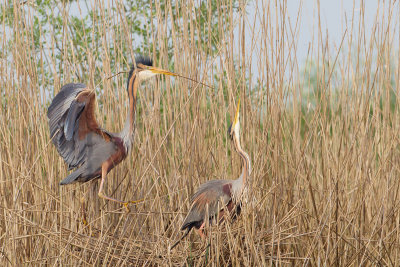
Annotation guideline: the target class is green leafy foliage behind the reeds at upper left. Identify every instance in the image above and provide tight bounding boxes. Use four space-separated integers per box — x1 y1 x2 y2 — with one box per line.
0 0 238 91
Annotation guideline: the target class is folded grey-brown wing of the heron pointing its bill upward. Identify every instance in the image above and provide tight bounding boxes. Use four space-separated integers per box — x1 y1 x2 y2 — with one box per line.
181 180 232 230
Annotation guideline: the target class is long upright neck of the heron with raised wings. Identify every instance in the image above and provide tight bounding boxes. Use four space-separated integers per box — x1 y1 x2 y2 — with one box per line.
121 73 139 152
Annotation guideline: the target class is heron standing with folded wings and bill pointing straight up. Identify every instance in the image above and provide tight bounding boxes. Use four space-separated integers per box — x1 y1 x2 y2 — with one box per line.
171 99 251 249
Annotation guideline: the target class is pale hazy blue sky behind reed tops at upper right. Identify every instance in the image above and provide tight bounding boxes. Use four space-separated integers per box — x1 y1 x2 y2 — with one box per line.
234 0 399 79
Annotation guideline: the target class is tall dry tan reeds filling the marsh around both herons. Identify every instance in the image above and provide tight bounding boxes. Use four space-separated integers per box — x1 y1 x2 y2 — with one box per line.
0 1 400 266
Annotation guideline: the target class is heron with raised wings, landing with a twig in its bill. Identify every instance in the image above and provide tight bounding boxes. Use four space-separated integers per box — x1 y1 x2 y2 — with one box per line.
47 56 175 206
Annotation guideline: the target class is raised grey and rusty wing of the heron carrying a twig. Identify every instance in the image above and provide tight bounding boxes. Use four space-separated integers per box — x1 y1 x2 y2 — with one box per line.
47 83 110 169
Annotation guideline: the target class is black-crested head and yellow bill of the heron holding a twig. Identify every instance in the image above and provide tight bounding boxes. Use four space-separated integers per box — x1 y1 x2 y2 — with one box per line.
128 56 176 86
